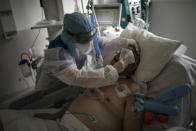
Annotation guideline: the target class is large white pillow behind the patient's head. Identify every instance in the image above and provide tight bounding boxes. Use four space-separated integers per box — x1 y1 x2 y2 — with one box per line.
121 24 180 83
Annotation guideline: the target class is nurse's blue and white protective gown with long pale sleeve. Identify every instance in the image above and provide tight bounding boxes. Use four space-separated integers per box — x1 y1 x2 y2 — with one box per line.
36 33 124 88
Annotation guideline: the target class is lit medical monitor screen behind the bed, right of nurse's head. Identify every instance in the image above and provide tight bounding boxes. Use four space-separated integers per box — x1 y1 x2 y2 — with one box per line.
94 3 122 26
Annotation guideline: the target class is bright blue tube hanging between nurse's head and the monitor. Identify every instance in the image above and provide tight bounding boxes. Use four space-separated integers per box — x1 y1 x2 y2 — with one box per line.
90 13 102 58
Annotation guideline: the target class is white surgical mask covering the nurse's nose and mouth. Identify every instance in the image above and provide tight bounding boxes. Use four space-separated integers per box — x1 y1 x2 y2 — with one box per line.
75 42 92 54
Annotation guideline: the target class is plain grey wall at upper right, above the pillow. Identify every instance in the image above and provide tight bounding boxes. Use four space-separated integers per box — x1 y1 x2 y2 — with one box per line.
150 0 196 59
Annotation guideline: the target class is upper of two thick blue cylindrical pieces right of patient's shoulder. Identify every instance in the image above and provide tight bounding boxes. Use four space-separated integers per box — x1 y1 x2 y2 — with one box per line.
156 83 192 102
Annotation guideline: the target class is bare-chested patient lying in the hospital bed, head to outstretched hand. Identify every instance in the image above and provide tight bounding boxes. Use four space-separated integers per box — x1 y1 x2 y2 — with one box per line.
35 46 142 131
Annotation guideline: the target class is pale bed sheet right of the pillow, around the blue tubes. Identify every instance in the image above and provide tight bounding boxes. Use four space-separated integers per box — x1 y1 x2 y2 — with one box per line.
145 55 196 131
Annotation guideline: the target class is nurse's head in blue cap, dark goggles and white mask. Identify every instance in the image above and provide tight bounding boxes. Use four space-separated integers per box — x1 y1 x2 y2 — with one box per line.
61 12 97 54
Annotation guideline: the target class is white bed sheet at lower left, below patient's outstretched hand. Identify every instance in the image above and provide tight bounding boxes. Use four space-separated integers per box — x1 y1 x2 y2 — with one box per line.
0 109 90 131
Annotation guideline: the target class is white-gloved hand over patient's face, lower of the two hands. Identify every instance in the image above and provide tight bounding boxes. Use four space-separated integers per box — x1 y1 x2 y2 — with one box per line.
113 48 135 73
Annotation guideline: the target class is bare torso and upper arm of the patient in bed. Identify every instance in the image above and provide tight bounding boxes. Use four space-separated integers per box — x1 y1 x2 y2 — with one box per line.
69 79 142 131
